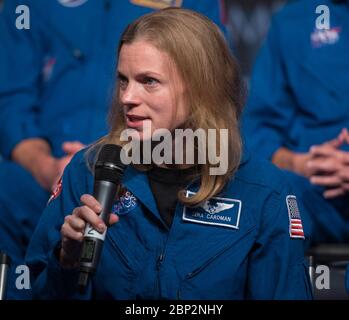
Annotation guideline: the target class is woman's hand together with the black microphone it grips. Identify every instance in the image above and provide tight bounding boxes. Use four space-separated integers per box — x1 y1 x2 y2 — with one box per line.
60 144 125 289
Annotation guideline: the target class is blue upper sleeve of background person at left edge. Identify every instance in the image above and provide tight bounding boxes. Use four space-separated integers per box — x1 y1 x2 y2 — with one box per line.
0 1 43 158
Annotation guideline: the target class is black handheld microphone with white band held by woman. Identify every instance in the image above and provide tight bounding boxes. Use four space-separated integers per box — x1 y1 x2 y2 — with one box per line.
78 144 126 291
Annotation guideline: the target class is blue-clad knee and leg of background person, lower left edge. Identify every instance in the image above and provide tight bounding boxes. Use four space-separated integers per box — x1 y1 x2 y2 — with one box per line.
0 162 48 299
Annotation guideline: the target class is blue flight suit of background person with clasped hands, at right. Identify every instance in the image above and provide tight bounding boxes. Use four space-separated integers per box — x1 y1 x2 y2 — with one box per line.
242 0 349 242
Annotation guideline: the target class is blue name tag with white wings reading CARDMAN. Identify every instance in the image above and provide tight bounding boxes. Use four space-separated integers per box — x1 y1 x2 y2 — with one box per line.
182 191 241 229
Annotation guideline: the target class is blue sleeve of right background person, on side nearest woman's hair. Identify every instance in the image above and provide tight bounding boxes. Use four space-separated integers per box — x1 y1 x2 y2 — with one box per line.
242 17 296 159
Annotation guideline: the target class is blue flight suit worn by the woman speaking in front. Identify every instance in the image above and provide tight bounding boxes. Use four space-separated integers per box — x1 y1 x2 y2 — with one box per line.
26 151 312 299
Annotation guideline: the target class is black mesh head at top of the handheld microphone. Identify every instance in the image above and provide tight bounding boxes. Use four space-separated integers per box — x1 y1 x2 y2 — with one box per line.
95 144 126 184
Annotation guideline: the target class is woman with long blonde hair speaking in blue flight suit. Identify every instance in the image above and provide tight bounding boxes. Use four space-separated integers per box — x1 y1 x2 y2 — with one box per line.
26 8 311 299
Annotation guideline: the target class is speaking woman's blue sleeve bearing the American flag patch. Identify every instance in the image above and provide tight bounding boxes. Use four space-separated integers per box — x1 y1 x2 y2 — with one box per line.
246 181 312 300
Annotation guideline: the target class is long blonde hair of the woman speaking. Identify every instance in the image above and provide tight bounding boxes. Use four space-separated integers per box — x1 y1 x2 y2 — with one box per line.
88 8 244 206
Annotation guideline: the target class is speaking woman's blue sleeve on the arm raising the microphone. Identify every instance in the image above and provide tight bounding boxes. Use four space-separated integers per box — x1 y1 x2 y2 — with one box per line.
26 151 92 299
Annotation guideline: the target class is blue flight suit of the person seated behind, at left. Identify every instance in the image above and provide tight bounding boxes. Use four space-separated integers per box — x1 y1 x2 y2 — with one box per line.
0 0 222 299
